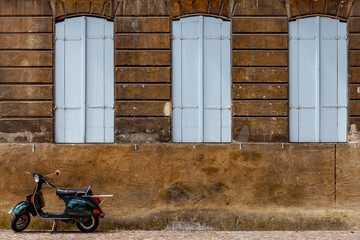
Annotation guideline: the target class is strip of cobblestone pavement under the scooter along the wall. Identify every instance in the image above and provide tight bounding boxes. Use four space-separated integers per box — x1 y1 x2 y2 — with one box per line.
0 230 360 240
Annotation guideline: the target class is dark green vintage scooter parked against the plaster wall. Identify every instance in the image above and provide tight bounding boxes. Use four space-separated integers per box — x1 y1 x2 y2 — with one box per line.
9 170 113 233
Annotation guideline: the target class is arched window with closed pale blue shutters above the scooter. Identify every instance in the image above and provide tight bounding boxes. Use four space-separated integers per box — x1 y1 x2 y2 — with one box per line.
55 17 114 143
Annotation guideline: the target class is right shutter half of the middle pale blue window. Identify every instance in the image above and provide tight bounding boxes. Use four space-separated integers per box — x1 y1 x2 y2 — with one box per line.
203 17 231 142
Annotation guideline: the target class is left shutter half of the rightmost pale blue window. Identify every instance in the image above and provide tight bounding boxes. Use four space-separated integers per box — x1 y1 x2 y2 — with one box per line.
290 17 319 142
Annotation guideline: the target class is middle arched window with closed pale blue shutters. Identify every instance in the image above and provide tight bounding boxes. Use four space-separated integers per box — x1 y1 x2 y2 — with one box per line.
172 16 231 142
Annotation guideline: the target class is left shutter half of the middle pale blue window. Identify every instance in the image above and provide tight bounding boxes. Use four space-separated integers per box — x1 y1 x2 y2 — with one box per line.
172 17 203 142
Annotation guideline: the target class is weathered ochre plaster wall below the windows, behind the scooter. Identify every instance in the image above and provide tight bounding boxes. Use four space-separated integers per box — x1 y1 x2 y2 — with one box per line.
0 144 360 229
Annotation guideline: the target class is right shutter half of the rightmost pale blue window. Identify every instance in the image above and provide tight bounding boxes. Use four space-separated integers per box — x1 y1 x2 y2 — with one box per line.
320 18 347 142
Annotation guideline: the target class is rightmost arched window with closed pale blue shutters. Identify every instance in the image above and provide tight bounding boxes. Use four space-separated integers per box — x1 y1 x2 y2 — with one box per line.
289 17 347 142
